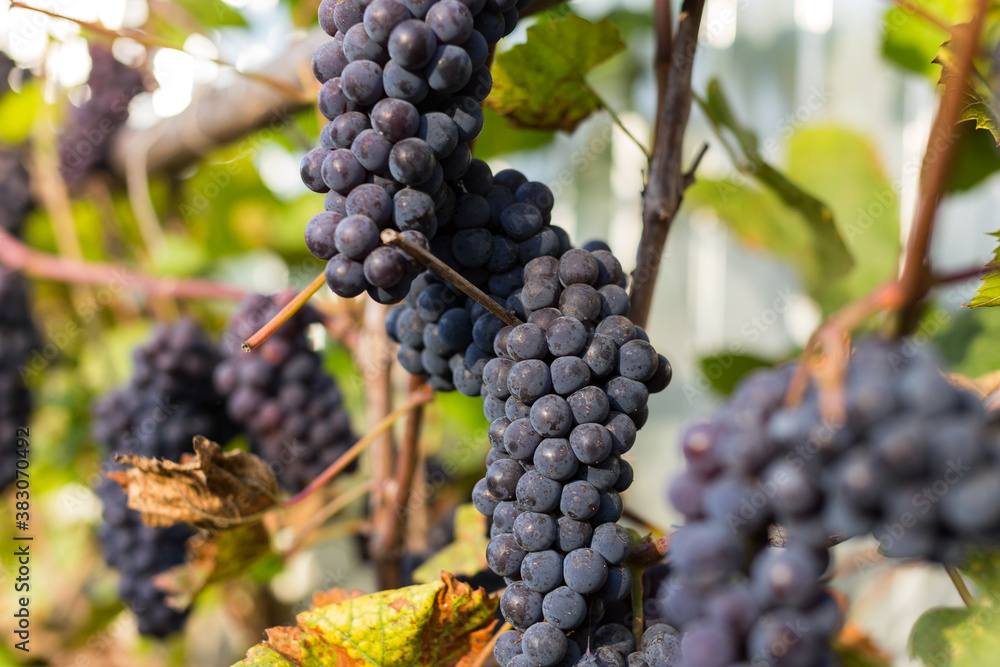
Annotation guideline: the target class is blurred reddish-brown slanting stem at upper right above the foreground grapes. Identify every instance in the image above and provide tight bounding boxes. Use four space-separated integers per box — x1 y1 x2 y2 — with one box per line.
897 0 989 333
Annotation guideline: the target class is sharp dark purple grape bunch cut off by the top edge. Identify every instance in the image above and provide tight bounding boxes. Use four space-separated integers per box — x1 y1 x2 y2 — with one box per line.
300 0 527 303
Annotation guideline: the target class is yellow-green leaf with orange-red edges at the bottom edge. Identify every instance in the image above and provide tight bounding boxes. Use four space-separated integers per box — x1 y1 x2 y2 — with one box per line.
234 574 498 667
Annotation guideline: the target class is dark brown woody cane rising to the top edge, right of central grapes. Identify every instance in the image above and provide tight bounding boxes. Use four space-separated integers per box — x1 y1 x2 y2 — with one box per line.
629 0 705 326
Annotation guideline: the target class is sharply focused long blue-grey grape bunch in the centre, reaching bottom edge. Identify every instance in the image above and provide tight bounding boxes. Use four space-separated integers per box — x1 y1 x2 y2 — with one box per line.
472 244 671 667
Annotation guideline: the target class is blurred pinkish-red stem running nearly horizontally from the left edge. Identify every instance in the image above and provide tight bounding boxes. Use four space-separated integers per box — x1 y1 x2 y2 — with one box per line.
0 228 246 299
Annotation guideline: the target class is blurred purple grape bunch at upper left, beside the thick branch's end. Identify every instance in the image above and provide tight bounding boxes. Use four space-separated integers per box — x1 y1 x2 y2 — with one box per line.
59 43 146 186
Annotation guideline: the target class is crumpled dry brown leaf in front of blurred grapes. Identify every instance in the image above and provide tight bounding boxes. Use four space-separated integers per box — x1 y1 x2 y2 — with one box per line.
108 436 278 530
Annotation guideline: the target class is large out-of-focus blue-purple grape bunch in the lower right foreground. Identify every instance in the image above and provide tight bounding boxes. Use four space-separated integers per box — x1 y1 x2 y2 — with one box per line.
660 341 1000 666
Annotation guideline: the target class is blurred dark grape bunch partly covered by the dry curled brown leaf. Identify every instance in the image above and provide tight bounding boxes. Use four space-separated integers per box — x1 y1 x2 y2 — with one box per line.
94 320 238 637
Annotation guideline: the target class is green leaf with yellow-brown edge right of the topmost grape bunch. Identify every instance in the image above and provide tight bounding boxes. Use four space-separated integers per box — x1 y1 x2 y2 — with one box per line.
486 15 625 132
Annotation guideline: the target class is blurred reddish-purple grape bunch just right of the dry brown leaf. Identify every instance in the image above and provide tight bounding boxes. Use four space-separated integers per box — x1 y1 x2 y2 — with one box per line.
214 295 357 492
